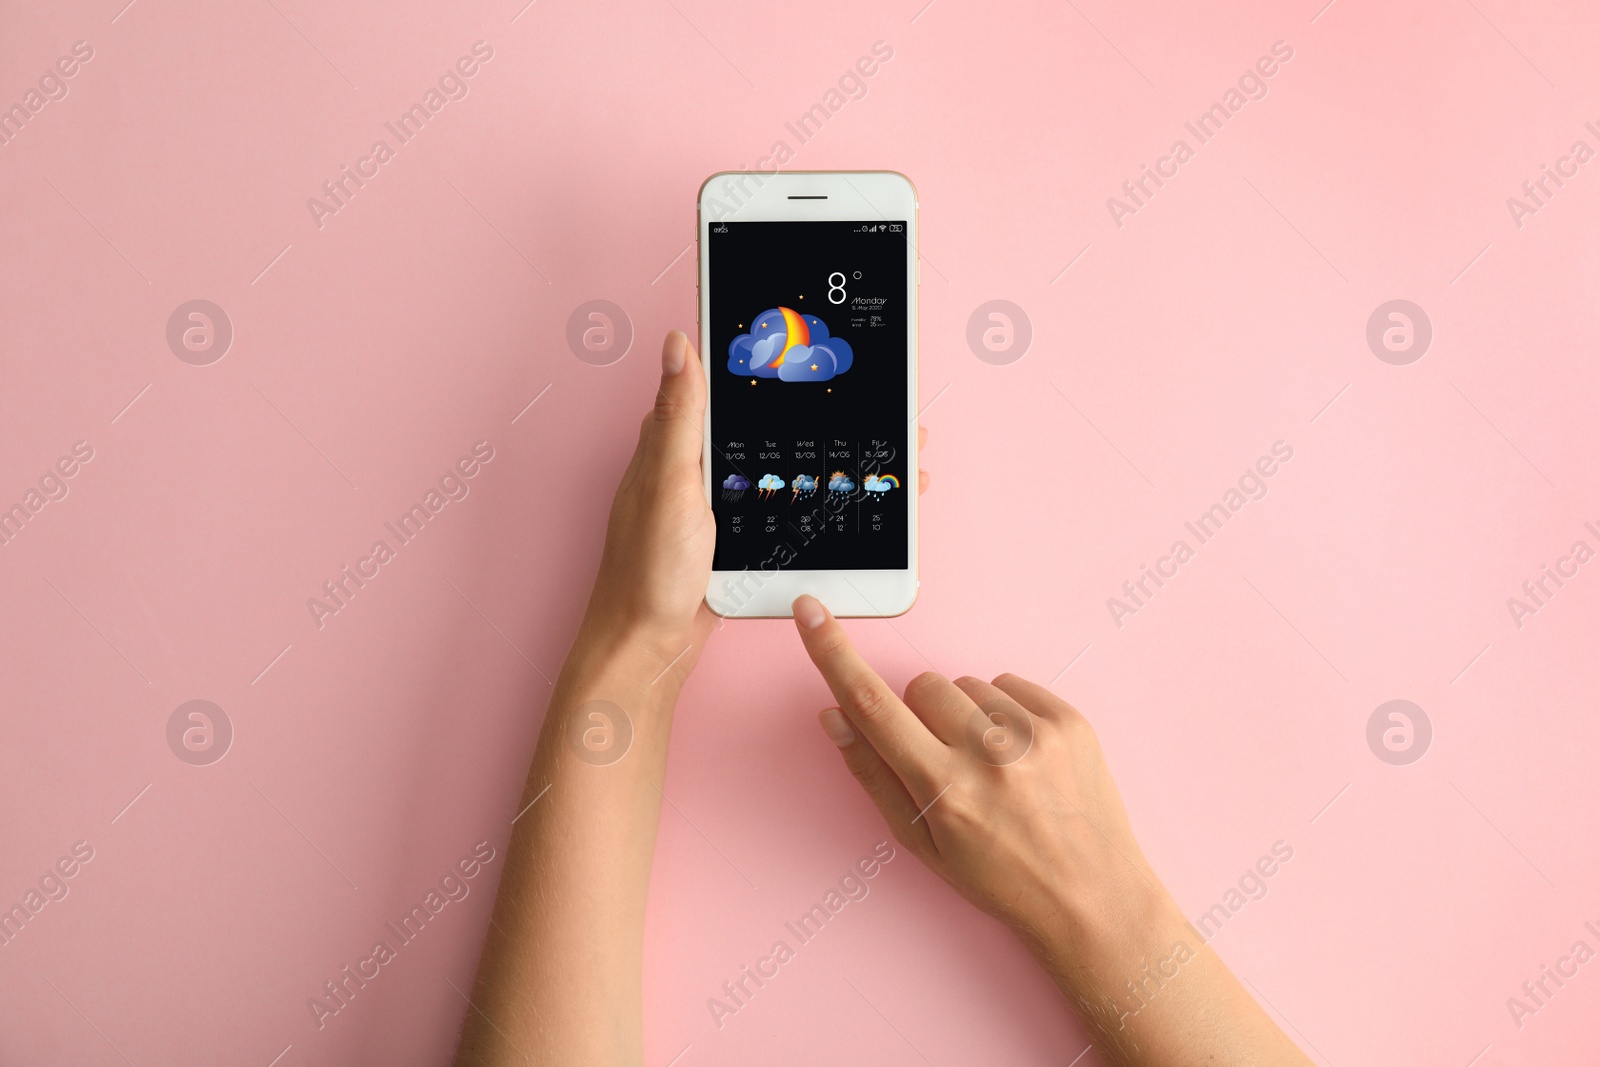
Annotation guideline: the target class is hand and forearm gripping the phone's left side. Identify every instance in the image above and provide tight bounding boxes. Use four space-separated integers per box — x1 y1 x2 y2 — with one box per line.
456 331 715 1067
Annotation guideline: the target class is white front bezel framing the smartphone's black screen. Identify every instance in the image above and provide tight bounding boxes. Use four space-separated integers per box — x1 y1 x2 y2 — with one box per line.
694 171 918 619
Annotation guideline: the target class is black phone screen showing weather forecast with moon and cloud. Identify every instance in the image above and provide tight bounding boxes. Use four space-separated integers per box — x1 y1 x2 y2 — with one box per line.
706 221 917 571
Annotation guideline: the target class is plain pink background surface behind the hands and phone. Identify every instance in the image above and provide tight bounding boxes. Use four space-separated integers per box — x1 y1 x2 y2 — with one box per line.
0 0 1600 1067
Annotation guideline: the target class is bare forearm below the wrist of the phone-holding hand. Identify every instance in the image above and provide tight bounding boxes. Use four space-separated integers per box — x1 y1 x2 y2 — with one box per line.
458 622 682 1067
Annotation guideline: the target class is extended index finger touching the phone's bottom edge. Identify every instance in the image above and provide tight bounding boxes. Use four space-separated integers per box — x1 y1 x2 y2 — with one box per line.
794 597 949 803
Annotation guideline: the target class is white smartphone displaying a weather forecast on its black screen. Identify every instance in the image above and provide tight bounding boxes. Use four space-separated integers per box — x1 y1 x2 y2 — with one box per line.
696 171 917 619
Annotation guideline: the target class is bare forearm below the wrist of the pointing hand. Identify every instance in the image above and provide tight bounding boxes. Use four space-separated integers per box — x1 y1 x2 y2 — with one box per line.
1024 885 1309 1067
